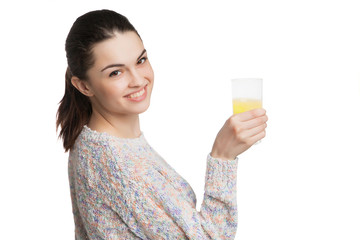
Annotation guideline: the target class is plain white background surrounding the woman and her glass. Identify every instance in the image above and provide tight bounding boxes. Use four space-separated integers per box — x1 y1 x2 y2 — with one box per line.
0 0 360 240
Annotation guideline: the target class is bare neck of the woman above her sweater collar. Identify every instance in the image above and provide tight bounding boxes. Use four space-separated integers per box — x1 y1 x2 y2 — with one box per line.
87 109 141 138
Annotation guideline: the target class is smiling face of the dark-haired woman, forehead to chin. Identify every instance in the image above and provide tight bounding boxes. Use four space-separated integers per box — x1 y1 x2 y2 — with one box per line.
87 31 154 116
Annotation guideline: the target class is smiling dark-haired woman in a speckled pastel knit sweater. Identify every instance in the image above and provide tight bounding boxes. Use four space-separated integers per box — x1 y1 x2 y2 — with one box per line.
57 10 267 240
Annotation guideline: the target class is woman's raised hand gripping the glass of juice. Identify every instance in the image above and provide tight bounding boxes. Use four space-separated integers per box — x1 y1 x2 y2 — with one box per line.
210 108 268 160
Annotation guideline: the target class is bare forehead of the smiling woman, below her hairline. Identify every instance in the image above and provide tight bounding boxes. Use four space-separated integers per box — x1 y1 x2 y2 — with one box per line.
92 31 144 67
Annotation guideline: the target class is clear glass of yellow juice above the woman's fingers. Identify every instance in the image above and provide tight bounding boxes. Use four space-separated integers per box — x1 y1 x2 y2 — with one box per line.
231 78 262 114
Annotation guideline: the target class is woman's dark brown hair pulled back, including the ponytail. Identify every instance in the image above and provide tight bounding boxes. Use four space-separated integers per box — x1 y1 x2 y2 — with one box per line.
56 10 141 152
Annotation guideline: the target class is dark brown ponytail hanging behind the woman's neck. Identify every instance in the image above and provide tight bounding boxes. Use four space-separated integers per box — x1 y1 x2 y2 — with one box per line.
56 67 92 152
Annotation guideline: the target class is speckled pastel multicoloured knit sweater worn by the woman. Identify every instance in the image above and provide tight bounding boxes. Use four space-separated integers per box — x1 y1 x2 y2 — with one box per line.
68 126 238 240
